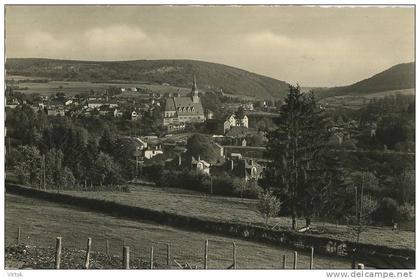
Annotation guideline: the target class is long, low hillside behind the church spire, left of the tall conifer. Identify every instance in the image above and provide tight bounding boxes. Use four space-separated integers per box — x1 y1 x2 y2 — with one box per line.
6 58 288 99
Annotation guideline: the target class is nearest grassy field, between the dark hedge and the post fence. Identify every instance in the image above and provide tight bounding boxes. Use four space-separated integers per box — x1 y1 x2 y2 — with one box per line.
5 194 350 268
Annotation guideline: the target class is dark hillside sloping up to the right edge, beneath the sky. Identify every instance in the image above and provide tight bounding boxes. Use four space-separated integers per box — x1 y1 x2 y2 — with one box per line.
315 62 415 97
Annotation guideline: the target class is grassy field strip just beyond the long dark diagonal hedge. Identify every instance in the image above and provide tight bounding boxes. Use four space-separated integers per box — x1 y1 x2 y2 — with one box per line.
56 185 415 249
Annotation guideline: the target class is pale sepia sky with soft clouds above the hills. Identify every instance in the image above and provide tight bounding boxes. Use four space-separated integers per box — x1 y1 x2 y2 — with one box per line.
5 5 415 86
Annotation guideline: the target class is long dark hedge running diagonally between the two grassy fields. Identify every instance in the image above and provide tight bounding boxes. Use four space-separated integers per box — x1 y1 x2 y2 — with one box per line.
6 184 415 268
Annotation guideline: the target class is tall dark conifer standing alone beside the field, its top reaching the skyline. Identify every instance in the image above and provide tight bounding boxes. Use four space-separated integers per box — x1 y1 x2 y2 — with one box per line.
262 86 330 229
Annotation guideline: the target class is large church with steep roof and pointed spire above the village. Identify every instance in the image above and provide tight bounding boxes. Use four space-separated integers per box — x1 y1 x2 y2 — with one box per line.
163 75 205 131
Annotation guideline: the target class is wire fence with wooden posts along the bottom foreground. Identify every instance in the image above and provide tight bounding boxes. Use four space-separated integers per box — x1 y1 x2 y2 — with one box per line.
6 227 322 269
